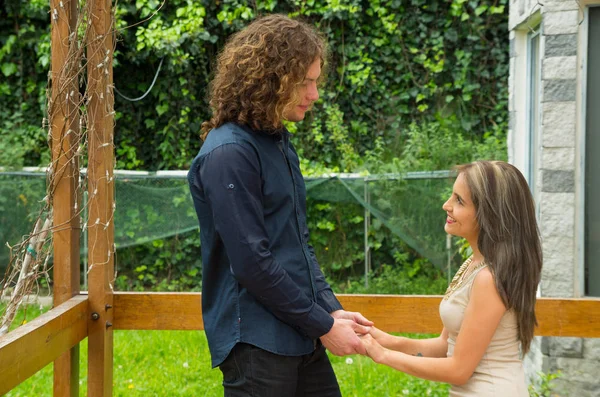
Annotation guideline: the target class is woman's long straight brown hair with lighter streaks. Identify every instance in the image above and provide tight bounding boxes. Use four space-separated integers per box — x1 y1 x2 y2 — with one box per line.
457 161 542 354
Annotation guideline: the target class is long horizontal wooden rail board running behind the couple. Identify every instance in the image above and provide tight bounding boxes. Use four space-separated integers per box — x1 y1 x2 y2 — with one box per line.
114 292 600 338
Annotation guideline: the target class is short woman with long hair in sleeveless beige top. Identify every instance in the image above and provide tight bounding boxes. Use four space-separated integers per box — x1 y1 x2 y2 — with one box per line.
362 161 542 397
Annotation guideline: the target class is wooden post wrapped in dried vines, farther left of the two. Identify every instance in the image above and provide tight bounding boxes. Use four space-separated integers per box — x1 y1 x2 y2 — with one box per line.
48 0 80 397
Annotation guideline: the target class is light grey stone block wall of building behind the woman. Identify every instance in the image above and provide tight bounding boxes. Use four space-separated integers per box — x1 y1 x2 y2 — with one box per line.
509 0 600 397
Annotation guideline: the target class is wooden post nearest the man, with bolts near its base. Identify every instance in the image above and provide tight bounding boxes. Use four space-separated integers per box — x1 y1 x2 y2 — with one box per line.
87 0 115 397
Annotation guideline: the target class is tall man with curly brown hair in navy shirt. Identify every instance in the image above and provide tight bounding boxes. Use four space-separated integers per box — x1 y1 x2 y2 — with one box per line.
188 15 373 397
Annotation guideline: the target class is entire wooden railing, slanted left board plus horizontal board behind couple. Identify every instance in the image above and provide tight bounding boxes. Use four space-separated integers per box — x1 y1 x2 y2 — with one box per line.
0 292 600 395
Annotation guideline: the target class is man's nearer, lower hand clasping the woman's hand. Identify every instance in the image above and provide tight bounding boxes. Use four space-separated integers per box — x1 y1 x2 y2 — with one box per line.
321 317 369 356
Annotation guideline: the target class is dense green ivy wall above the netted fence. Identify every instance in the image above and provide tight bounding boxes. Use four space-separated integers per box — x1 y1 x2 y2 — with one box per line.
0 0 508 171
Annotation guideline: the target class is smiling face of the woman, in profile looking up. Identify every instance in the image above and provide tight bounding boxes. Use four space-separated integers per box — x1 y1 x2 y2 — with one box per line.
442 173 479 245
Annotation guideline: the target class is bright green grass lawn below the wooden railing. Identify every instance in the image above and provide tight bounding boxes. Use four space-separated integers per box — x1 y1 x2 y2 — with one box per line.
6 306 449 397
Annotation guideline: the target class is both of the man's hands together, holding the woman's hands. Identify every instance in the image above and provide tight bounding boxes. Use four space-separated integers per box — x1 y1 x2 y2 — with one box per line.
321 310 373 356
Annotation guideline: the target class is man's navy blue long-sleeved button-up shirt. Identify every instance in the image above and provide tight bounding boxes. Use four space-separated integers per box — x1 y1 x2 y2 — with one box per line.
188 123 342 367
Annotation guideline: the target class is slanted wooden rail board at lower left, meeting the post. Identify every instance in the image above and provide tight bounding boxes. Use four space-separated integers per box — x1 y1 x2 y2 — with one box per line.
0 295 88 396
